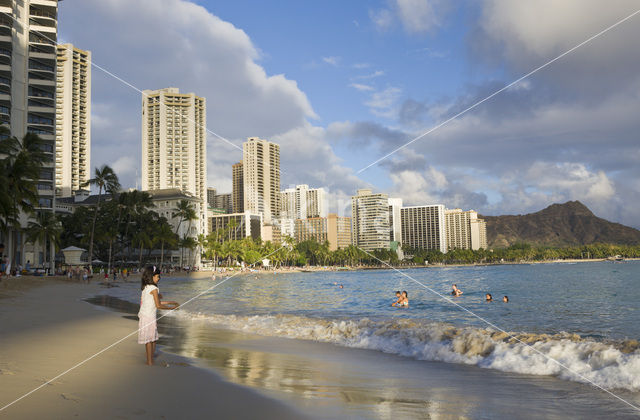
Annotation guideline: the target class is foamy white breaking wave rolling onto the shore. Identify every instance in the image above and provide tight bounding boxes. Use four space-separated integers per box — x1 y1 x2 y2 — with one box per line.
166 311 640 391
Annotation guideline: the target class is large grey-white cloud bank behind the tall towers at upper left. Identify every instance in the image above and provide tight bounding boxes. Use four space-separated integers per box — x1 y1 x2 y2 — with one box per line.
59 0 317 190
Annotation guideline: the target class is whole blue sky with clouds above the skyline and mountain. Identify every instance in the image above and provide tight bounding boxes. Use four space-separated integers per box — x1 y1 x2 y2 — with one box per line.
58 0 640 228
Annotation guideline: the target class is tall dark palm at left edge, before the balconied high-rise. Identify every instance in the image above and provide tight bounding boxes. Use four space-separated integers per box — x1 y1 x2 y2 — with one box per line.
0 130 51 265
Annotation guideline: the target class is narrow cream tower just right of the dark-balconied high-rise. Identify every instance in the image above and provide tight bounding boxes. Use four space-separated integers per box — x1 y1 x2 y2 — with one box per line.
56 44 91 197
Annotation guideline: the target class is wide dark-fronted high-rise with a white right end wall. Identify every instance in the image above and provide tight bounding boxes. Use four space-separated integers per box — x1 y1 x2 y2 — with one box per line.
400 204 447 253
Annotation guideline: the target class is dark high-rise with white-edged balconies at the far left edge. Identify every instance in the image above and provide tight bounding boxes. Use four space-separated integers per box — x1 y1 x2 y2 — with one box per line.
0 0 58 209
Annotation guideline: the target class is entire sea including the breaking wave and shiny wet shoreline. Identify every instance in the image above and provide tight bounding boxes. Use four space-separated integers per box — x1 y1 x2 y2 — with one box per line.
91 261 640 418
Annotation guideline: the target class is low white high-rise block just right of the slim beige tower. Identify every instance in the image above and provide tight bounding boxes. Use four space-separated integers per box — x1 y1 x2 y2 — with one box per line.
280 185 327 219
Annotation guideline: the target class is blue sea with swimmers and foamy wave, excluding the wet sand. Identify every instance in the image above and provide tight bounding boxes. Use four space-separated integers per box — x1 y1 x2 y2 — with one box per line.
104 262 640 393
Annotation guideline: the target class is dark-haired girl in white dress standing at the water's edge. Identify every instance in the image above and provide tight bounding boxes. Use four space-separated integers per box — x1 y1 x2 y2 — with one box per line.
138 265 179 366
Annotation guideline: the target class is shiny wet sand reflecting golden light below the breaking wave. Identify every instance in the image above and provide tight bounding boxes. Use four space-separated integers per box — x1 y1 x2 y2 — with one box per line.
91 298 638 419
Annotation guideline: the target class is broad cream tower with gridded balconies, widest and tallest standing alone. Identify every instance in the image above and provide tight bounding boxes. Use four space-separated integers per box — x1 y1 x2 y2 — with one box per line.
142 88 207 233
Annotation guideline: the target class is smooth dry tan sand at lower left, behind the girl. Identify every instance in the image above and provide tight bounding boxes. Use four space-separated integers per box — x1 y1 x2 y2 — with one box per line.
0 277 304 419
